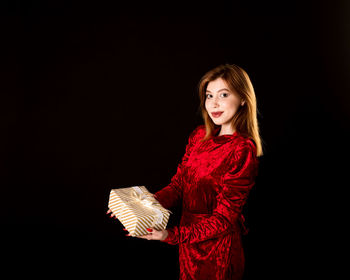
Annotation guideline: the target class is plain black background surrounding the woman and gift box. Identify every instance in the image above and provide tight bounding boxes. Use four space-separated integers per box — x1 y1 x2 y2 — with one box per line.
0 1 350 279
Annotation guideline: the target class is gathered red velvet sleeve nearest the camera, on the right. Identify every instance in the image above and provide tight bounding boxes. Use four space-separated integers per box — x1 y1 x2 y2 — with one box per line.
163 142 258 244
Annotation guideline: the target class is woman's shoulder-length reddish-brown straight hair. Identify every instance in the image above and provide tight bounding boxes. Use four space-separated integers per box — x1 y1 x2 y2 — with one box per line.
198 64 263 157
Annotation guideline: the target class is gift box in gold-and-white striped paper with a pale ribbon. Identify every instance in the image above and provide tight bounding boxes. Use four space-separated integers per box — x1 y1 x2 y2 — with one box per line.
108 186 170 236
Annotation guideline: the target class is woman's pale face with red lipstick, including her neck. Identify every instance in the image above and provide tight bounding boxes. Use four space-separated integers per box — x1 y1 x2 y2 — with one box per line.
205 78 242 133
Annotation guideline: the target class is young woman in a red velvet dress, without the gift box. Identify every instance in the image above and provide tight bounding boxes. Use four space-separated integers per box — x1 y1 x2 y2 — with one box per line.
109 64 263 280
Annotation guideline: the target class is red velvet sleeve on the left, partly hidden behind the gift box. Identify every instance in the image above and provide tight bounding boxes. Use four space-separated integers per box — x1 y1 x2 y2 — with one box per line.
154 125 205 209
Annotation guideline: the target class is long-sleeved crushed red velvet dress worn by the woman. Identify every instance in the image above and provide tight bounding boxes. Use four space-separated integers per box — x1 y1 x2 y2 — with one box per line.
155 125 259 280
